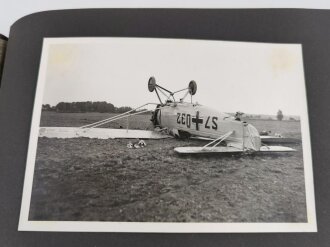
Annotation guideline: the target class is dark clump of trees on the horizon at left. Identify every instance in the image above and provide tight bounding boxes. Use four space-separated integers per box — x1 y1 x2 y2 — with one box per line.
42 101 132 113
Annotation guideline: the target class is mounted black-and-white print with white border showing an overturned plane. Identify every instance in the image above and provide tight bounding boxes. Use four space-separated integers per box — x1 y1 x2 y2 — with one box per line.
19 37 317 232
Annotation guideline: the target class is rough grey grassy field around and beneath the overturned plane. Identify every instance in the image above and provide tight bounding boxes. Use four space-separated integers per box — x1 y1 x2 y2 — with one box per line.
29 112 307 222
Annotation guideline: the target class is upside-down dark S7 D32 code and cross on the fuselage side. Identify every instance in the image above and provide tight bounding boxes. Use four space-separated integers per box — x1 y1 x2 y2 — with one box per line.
176 111 218 130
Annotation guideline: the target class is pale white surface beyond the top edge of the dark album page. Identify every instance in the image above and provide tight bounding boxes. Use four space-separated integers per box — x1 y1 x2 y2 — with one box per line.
0 0 330 36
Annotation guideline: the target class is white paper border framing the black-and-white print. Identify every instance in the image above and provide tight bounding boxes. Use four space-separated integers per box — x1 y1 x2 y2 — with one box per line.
18 37 317 233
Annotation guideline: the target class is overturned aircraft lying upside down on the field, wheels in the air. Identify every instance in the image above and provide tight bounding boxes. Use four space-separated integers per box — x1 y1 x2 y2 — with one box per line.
39 77 296 154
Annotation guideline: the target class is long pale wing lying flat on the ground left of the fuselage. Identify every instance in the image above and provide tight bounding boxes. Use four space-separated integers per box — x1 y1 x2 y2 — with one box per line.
39 127 171 139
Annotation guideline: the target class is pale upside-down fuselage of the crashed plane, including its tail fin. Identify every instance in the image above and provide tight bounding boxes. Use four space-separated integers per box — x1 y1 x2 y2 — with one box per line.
154 102 261 150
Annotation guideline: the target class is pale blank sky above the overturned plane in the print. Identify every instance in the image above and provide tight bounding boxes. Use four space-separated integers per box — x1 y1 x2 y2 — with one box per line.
38 38 306 115
